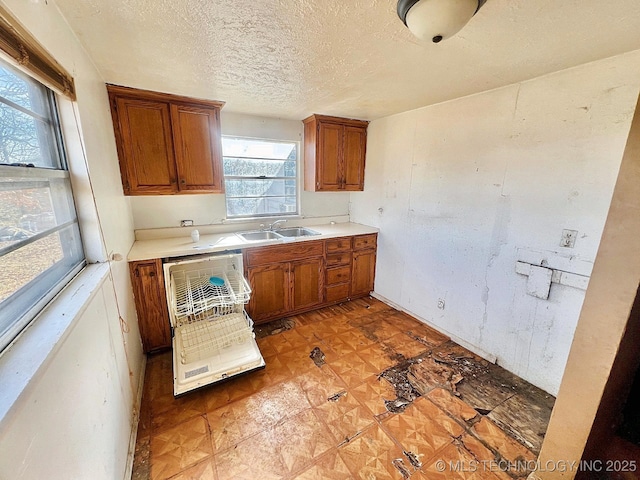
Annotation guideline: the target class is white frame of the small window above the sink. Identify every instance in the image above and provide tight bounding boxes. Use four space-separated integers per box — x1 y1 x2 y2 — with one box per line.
221 134 302 221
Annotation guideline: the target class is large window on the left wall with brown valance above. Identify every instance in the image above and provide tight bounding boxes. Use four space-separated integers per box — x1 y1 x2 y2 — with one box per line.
0 63 85 350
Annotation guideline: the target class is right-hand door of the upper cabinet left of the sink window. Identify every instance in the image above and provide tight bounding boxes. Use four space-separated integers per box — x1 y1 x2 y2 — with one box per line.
171 104 223 193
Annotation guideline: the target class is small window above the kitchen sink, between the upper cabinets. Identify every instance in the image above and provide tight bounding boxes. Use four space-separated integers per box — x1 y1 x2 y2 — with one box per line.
222 136 299 218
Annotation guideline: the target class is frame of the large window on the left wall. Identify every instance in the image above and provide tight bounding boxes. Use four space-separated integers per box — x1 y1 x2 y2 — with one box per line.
0 60 87 354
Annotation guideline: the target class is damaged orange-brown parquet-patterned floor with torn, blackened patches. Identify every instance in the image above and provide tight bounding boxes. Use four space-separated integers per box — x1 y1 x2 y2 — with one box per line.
132 298 554 480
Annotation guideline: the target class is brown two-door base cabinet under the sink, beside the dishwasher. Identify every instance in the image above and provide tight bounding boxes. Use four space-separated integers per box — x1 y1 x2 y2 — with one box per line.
244 241 324 323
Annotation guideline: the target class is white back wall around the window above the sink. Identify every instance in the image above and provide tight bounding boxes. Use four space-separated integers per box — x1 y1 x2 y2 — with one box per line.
131 109 349 230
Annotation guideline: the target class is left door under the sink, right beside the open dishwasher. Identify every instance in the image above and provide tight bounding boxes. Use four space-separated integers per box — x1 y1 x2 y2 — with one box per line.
247 263 291 323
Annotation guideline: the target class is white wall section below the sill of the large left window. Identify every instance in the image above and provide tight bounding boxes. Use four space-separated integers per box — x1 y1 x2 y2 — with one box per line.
0 270 131 480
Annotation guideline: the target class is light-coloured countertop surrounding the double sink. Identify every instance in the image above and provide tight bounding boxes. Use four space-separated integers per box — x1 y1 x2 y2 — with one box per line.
127 222 378 262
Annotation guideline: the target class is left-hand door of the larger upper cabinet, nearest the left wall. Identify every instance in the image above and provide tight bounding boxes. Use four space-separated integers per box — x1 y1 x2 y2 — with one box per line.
115 97 178 195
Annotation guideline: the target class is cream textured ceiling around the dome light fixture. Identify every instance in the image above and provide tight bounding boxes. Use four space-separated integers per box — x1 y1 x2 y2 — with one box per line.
55 0 640 120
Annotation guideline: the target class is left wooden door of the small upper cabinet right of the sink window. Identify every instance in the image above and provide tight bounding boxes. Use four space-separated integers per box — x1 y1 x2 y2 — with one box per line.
316 122 344 191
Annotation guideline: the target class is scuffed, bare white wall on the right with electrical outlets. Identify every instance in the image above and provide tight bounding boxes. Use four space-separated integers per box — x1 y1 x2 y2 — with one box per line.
351 51 640 394
